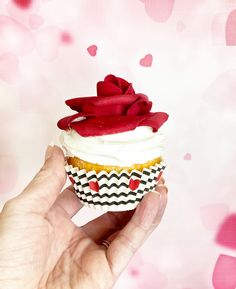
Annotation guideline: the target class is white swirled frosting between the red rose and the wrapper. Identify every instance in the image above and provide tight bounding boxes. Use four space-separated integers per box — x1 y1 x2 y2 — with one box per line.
60 126 164 167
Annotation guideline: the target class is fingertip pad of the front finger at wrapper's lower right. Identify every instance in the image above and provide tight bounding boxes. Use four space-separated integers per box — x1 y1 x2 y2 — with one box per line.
134 191 161 230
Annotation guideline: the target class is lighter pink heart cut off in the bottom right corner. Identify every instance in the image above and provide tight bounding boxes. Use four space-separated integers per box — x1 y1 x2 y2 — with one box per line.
212 255 236 289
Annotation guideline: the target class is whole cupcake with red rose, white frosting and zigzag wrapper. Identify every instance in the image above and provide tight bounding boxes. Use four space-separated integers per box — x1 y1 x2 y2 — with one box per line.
58 75 168 211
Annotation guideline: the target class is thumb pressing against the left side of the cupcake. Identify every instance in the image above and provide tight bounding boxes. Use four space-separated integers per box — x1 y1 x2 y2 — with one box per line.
6 146 66 214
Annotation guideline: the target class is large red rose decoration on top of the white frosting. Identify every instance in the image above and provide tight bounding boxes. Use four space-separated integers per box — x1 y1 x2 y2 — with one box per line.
57 75 168 137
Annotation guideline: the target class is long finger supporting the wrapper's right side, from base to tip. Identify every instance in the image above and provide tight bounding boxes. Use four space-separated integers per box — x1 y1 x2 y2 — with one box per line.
106 186 167 278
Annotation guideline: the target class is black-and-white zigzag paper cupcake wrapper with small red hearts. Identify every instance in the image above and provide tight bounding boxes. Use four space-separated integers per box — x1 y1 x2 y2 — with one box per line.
65 162 166 211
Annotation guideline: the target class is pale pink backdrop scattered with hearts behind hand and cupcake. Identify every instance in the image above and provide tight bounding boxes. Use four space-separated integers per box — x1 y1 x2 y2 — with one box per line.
0 0 236 289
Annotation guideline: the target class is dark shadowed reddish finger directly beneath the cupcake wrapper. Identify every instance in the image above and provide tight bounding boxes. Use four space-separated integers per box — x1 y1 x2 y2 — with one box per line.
82 210 134 244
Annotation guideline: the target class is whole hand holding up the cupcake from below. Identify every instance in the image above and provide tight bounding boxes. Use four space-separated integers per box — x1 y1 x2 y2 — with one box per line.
0 146 167 289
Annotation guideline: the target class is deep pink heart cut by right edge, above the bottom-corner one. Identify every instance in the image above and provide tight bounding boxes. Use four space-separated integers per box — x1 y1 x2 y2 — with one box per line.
216 214 236 249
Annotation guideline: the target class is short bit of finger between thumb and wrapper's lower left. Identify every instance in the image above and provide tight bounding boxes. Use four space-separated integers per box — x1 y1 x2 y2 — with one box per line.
53 186 83 218
